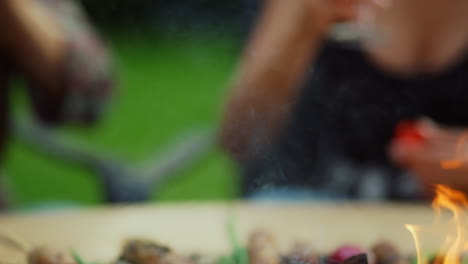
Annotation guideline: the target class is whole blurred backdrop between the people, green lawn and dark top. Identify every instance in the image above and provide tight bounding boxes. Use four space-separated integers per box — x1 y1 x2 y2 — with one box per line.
5 0 257 208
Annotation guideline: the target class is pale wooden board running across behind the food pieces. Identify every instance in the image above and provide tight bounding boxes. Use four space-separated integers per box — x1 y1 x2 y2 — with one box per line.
0 203 439 263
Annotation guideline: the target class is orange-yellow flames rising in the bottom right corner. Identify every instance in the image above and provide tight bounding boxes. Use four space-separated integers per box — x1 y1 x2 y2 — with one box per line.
405 185 468 264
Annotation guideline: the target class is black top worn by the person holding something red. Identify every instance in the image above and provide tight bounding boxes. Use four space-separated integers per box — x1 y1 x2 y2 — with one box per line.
244 41 468 199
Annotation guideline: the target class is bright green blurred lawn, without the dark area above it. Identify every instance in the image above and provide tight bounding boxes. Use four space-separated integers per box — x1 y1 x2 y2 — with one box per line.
5 32 238 207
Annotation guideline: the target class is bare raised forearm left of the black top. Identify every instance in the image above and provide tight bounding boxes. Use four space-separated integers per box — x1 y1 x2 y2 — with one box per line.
221 0 353 161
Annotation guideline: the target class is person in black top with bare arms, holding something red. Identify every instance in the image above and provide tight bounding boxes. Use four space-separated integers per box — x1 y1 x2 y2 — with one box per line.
222 0 468 199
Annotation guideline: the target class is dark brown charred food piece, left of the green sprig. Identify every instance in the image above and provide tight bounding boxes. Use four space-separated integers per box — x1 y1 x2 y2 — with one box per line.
119 240 191 264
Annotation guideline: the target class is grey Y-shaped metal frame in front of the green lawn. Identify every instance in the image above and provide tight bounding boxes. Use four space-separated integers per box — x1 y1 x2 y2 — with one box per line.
14 120 216 203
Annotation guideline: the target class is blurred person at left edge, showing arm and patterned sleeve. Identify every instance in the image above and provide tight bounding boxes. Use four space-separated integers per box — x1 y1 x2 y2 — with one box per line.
0 0 113 207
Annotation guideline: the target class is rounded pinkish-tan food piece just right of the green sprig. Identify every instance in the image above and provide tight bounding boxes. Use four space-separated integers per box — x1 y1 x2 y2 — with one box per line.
248 231 281 264
